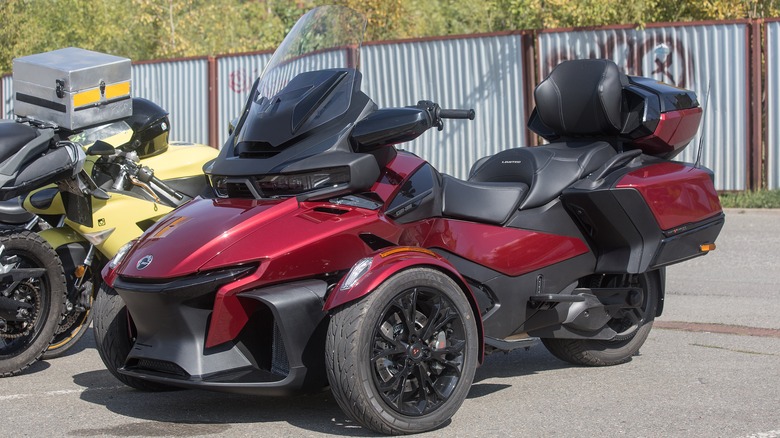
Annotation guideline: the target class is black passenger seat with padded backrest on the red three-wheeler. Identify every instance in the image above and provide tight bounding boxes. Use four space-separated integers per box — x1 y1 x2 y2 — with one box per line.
458 59 628 216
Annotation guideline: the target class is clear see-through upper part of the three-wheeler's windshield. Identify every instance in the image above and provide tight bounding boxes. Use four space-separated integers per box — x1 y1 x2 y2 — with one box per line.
255 6 366 101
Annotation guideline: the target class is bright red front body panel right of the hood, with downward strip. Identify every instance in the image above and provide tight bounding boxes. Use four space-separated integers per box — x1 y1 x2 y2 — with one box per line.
194 201 401 346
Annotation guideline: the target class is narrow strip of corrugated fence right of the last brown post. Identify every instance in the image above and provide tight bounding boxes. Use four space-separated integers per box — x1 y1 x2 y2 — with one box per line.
764 21 780 189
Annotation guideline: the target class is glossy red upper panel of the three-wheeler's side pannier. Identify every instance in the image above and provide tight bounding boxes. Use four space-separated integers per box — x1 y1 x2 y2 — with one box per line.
616 162 722 230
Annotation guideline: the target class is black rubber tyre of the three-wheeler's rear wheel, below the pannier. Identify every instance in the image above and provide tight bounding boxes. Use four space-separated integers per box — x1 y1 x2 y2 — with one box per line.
542 271 661 367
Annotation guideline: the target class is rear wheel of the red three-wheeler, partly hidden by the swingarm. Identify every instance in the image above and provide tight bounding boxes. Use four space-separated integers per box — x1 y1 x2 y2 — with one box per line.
542 271 662 366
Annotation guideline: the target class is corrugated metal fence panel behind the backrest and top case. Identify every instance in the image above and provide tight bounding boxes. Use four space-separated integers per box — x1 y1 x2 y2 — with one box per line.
537 23 749 190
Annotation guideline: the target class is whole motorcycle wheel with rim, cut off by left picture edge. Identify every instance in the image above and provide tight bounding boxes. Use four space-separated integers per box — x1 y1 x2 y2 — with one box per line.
0 231 65 377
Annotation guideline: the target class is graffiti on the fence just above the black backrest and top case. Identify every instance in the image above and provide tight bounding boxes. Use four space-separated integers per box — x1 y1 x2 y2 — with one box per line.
540 31 695 89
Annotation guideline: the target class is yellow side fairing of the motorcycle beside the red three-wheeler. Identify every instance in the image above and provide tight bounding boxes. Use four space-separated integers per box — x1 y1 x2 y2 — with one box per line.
65 192 173 259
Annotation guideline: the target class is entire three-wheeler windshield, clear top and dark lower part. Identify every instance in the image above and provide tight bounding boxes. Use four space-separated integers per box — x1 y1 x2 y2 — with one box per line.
236 6 366 151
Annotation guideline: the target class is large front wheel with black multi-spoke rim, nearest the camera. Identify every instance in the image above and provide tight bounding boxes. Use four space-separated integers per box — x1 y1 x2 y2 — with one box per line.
325 268 479 434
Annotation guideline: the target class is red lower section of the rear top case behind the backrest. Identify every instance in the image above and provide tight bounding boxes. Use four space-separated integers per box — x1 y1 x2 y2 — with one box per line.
634 107 702 155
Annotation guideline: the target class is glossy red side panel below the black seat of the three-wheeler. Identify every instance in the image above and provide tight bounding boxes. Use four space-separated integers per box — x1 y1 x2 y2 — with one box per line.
423 218 589 277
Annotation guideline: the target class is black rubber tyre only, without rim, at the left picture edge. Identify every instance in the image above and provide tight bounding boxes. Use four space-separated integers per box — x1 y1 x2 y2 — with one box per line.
0 231 66 377
